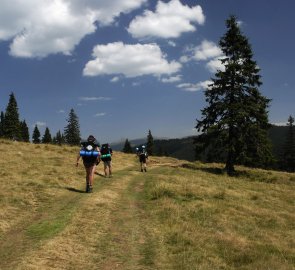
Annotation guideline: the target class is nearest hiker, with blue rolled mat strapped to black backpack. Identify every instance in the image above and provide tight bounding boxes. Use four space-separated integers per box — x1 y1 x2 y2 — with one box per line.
76 135 101 193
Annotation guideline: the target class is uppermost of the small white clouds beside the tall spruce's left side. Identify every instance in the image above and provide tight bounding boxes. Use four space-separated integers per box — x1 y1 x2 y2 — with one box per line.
194 40 222 61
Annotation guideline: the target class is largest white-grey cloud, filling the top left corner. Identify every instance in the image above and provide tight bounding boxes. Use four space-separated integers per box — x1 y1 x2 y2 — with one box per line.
0 0 146 58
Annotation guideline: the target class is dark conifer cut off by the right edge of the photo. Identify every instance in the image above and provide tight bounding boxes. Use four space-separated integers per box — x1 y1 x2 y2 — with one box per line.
282 115 295 172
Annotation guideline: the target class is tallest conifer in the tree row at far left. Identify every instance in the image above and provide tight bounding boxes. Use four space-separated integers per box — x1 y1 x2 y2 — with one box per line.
3 93 21 140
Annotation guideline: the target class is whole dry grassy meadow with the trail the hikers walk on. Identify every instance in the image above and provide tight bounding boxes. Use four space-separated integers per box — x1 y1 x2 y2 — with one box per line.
0 140 295 270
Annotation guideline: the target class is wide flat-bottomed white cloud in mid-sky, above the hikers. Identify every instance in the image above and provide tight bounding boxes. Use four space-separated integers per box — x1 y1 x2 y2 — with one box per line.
83 42 181 78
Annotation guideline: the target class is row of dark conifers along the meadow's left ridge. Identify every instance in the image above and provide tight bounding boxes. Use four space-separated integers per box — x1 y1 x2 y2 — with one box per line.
0 92 81 148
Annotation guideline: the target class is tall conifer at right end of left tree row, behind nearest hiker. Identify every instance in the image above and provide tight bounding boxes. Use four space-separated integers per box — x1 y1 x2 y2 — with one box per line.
64 109 81 145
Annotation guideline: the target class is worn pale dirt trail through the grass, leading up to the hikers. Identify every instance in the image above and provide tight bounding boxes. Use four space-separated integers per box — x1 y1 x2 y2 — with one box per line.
0 158 158 270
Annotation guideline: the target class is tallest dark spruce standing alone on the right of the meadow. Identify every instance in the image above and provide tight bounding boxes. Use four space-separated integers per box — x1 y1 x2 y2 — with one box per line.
195 16 273 175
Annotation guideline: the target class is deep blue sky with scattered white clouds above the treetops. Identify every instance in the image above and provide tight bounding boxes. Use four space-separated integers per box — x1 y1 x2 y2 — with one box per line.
0 0 295 143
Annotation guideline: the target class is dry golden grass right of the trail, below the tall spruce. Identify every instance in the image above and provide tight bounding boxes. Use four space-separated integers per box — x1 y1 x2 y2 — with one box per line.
146 163 295 269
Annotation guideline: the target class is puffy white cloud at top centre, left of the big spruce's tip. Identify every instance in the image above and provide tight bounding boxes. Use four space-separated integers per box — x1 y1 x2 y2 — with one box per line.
128 0 205 38
